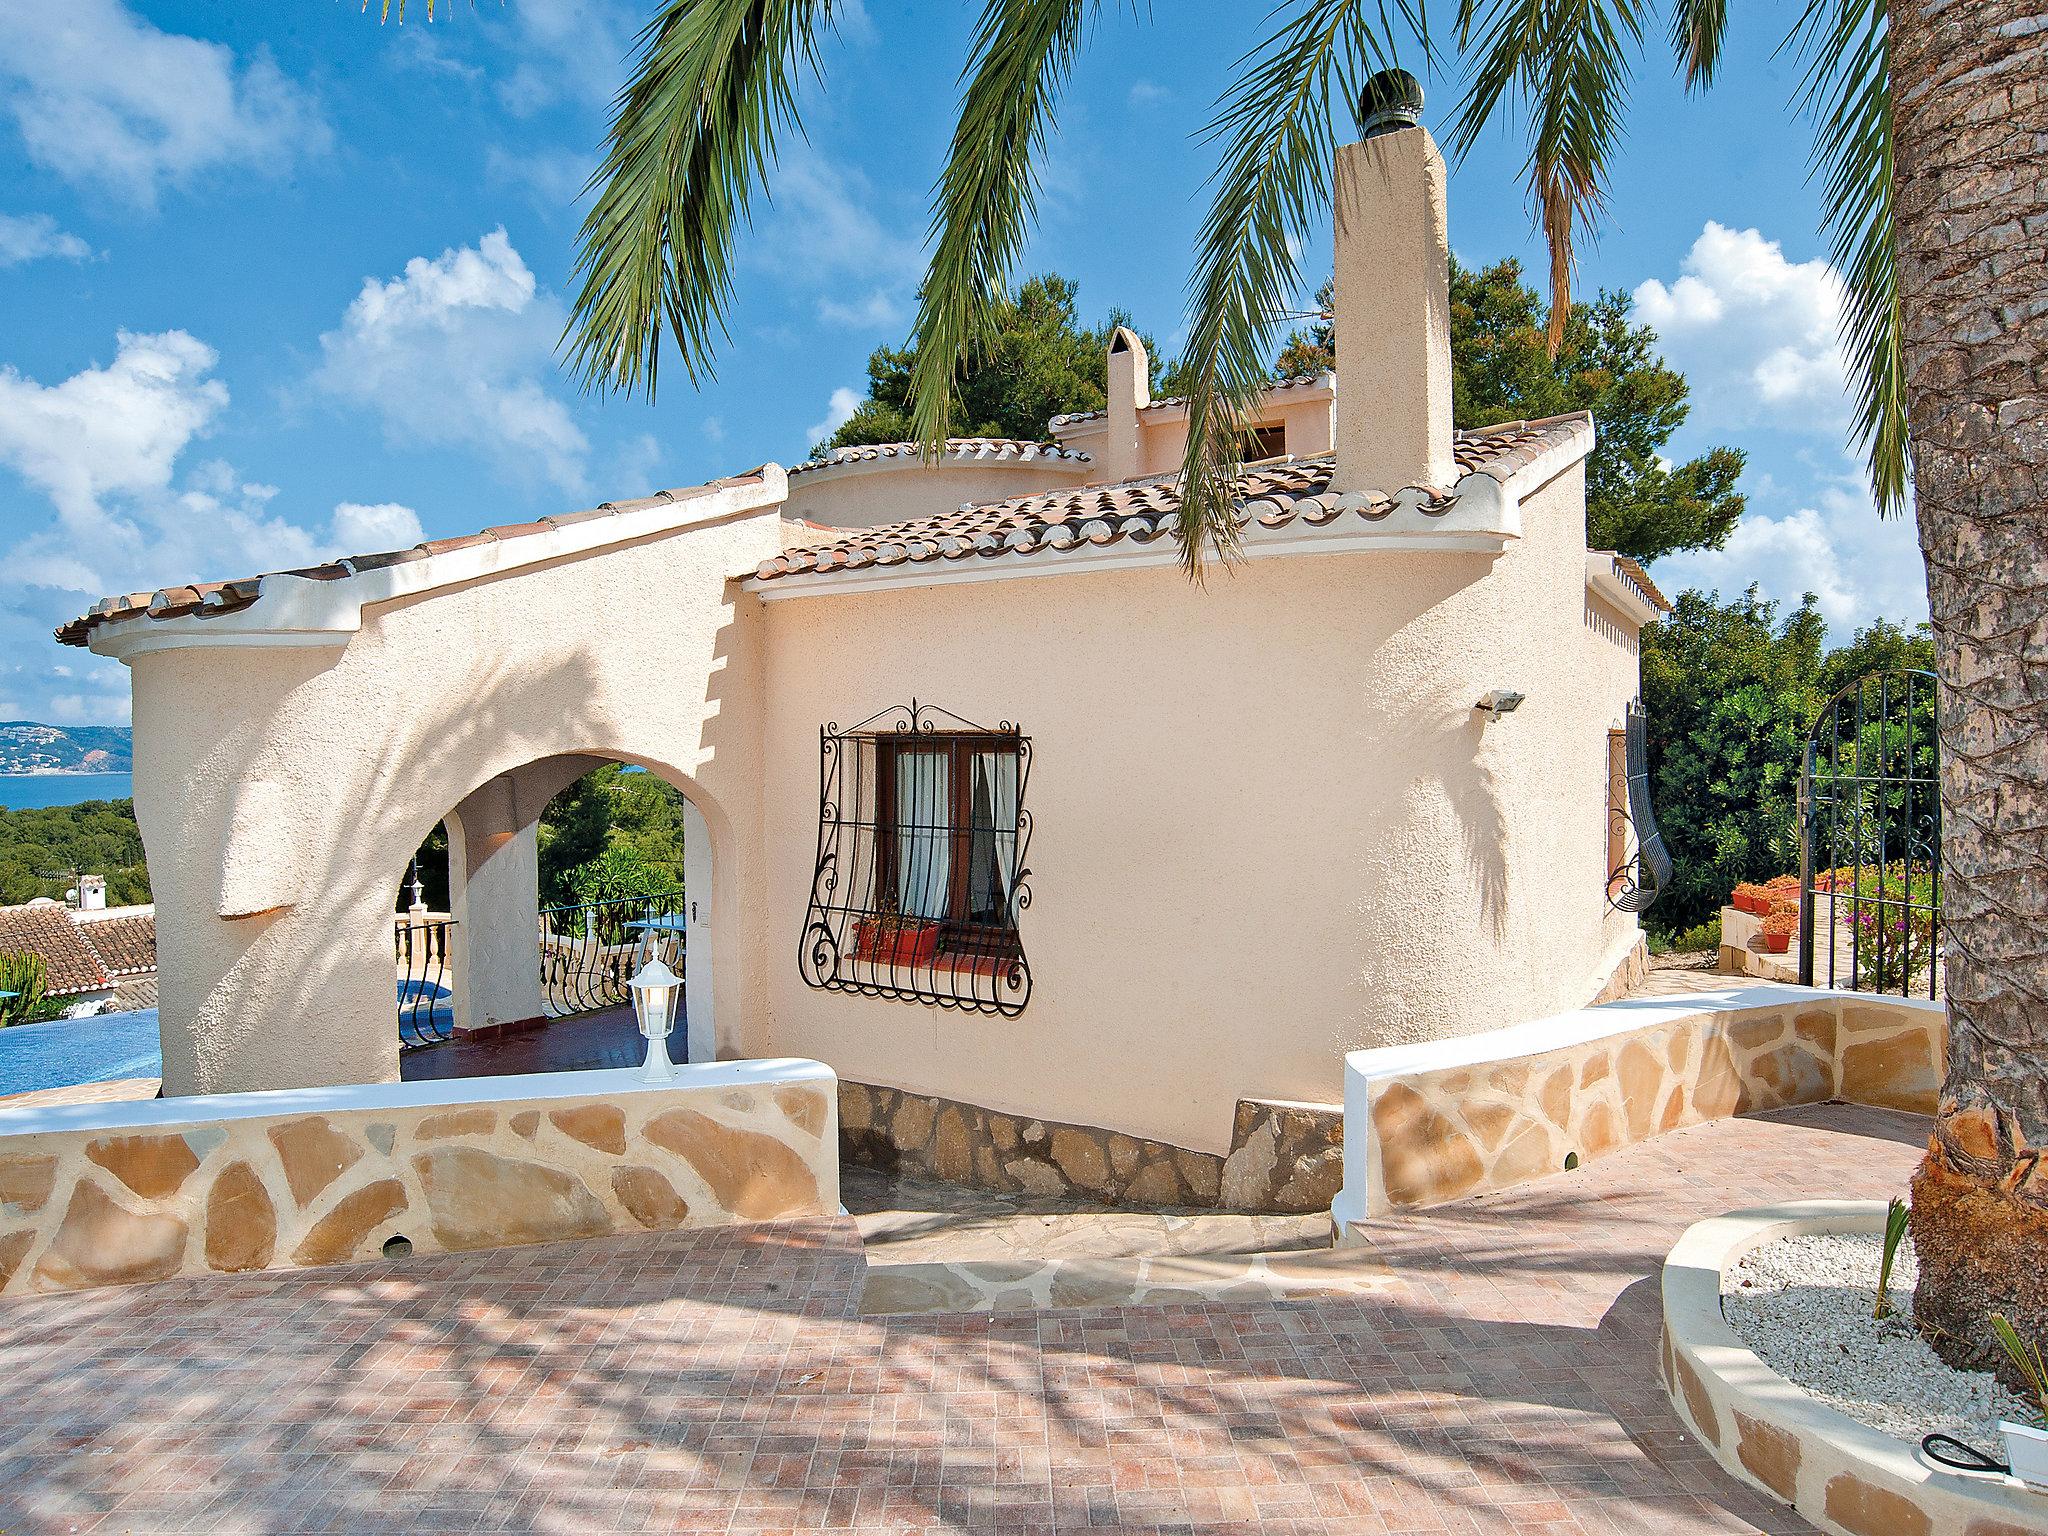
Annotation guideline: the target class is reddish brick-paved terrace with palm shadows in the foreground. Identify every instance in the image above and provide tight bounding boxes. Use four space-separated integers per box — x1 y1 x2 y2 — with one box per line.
0 1106 1925 1536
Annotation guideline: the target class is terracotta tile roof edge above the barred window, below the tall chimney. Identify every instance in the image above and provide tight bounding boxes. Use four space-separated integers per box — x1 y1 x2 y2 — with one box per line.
756 412 1591 582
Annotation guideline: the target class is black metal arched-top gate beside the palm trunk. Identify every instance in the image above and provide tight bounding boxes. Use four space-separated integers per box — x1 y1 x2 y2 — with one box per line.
1798 668 1942 997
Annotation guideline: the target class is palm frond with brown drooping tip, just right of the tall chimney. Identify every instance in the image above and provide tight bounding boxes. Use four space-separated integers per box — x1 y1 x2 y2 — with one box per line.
1450 0 1649 356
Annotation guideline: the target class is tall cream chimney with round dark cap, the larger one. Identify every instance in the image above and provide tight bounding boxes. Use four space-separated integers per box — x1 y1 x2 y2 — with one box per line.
1333 70 1456 496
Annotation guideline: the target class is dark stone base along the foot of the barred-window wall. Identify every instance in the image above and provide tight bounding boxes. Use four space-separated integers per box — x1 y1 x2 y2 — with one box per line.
840 1081 1343 1214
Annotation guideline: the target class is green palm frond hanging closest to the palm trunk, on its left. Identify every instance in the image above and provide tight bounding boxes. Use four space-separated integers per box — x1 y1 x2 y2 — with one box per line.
1788 0 1911 516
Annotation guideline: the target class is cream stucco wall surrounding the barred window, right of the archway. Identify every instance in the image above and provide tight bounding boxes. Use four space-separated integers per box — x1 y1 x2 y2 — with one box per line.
745 456 1636 1151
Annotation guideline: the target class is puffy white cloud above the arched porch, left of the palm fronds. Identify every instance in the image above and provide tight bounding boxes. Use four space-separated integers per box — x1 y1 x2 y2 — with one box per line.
315 229 590 496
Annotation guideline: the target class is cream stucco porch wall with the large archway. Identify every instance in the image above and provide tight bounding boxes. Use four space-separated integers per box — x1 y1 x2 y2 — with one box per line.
129 501 780 1094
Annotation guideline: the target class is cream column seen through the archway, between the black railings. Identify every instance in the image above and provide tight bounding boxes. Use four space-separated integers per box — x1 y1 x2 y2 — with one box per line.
446 778 541 1034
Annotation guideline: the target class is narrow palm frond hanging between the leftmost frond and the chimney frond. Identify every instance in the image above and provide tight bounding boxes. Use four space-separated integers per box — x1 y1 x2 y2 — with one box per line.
911 0 1100 459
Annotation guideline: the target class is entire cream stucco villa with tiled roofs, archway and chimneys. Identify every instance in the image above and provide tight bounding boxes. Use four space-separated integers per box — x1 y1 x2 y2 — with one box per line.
48 102 1665 1208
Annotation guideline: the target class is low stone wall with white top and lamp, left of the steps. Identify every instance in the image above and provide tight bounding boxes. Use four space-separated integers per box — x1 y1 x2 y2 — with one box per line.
0 1063 840 1294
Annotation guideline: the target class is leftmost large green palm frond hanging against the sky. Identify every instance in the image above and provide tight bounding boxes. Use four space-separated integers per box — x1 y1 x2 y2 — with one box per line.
563 0 831 397
